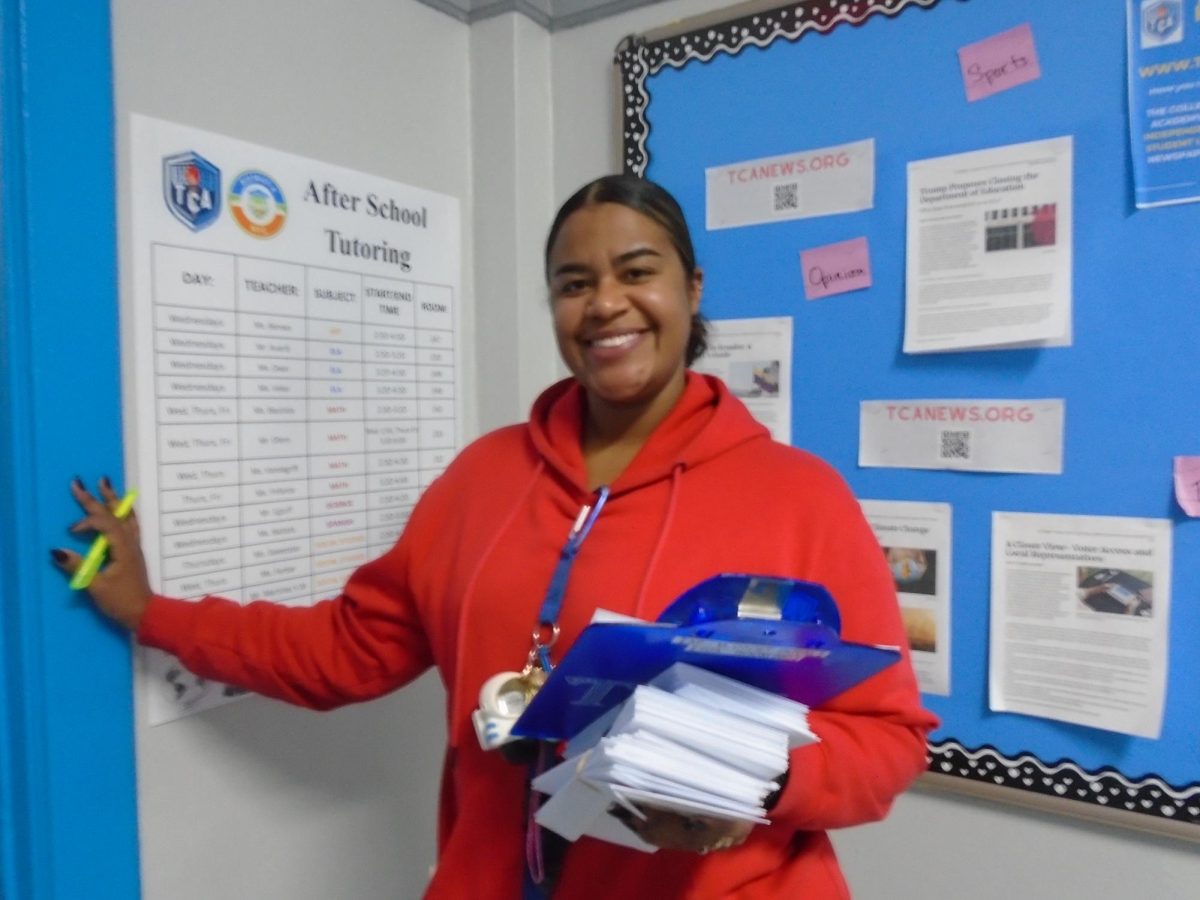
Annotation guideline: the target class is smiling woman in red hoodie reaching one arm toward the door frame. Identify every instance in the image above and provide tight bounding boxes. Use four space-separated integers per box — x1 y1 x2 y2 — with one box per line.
56 176 935 900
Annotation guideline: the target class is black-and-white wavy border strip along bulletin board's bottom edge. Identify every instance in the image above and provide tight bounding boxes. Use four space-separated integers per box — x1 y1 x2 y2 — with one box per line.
929 740 1200 824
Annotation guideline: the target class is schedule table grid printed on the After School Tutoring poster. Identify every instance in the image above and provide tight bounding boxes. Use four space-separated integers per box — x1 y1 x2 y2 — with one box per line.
151 242 457 604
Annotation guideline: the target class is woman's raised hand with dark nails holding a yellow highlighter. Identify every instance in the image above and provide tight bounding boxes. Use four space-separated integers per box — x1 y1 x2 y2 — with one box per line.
50 478 154 631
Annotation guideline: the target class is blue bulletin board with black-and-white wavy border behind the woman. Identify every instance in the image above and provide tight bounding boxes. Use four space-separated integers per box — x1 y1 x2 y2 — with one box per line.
616 0 1200 836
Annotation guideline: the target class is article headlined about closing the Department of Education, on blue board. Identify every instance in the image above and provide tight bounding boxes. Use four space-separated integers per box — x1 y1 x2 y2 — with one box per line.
904 137 1073 353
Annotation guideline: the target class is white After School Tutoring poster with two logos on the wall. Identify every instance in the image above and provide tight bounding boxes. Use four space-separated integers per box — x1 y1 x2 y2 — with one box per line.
129 115 462 724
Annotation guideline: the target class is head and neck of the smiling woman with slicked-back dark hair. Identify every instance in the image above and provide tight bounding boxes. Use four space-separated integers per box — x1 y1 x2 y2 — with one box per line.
546 175 706 487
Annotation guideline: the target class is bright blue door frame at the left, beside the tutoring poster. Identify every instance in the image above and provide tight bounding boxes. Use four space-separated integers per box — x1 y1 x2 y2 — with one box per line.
0 0 140 900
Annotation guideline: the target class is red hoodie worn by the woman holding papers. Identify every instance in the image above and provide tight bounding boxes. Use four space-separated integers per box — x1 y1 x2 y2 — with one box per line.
138 373 936 900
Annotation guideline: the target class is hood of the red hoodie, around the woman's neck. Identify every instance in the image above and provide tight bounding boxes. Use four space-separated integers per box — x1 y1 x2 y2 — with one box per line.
529 372 769 496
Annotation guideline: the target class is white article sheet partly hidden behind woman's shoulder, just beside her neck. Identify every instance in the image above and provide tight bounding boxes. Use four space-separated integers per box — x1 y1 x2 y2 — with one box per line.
692 316 792 444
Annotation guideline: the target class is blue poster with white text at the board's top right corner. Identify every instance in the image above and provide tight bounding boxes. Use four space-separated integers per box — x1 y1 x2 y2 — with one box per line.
1126 0 1200 209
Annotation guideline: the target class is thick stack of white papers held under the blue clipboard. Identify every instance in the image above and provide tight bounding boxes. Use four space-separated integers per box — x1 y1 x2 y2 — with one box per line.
533 664 817 852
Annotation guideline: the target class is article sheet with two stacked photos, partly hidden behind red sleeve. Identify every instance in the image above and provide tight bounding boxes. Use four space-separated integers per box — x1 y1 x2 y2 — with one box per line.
859 500 952 697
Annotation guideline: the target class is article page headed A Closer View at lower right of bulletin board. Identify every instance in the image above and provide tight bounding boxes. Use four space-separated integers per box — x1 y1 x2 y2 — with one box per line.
989 512 1171 738
